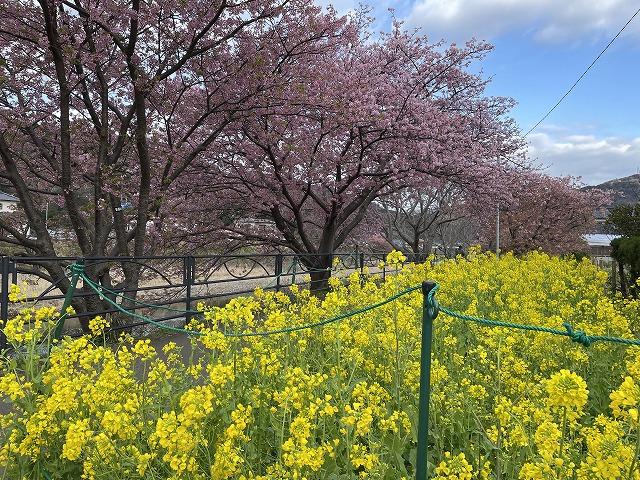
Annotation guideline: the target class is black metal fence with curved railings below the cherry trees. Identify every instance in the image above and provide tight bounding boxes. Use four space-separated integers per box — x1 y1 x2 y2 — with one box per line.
0 250 400 348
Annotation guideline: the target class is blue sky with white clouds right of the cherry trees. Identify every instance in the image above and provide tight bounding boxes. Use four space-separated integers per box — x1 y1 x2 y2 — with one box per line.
321 0 640 185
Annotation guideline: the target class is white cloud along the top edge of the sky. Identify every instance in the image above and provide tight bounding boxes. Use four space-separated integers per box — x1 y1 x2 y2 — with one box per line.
407 0 640 42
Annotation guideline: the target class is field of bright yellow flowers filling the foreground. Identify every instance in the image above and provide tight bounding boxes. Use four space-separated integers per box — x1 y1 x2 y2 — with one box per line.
0 253 640 480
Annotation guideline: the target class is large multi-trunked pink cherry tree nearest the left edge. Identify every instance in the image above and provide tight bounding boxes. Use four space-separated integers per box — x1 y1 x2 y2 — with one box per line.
0 0 347 324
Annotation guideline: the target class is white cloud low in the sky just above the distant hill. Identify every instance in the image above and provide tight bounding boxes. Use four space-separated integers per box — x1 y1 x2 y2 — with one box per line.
529 130 640 185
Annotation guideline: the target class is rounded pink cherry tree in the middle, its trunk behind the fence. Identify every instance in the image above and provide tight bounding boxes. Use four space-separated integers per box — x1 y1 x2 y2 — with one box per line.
211 20 521 288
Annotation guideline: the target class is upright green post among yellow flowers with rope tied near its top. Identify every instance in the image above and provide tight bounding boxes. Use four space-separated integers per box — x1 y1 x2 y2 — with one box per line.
416 282 438 480
